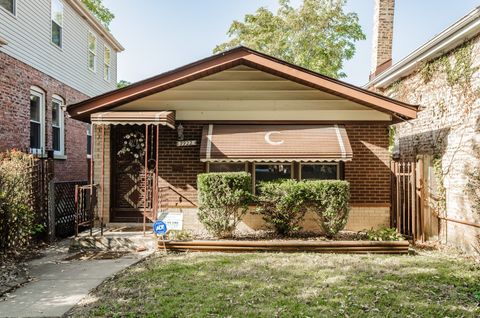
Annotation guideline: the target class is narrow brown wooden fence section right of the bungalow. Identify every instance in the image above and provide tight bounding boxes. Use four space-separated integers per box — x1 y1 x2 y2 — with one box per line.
390 160 424 243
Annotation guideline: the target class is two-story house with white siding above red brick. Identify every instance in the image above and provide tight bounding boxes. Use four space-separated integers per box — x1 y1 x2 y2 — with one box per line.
0 0 123 180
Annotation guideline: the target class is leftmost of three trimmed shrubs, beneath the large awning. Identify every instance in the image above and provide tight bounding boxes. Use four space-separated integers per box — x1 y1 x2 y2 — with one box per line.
197 172 252 237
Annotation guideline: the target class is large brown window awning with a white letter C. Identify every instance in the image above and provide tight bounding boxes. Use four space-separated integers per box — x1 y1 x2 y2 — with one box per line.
200 124 353 162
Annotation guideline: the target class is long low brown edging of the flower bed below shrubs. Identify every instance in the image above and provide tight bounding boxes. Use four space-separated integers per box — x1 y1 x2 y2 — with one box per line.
158 240 410 254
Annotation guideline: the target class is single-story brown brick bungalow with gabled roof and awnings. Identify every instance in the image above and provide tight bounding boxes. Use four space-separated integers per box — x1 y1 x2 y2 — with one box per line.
68 47 417 232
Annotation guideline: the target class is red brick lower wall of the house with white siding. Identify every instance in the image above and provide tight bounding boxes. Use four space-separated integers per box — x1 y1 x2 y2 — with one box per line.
0 52 88 181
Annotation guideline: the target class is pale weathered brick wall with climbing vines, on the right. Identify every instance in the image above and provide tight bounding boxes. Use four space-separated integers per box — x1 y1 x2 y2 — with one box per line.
381 37 480 251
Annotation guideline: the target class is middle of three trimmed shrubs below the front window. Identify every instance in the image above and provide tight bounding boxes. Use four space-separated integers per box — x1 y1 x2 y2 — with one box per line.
257 180 308 235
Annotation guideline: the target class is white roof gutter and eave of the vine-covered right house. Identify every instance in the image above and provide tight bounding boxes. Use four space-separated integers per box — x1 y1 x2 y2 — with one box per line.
364 6 480 89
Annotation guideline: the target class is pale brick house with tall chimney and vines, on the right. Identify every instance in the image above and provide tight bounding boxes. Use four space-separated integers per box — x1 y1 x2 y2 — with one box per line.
366 1 480 251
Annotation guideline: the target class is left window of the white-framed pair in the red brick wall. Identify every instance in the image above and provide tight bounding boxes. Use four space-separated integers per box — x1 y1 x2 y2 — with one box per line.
30 87 45 155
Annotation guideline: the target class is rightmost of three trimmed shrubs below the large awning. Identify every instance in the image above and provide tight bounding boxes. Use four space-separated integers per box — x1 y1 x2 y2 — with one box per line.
305 180 350 237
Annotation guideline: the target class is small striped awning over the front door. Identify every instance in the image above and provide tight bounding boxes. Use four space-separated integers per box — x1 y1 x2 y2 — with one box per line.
90 111 175 128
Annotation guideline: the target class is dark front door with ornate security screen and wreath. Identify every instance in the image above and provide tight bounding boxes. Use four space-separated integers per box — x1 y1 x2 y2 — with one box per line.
111 125 153 223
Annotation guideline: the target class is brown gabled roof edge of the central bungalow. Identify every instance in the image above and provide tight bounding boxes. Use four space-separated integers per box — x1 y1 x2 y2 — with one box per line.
67 47 418 121
